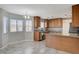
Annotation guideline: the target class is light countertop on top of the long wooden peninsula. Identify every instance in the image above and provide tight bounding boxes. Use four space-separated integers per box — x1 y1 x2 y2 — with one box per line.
47 33 79 38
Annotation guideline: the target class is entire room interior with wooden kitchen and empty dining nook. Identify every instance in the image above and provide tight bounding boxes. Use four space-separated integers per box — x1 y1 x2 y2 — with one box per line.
0 4 79 54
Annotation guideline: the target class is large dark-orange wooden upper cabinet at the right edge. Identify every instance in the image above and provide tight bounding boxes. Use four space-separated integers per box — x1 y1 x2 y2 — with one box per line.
72 5 79 27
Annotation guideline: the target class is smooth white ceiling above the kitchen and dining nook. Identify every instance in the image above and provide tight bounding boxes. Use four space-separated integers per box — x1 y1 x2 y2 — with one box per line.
0 4 72 18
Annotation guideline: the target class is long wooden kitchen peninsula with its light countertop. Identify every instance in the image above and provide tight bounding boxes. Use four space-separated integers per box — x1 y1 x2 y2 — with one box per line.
45 33 79 53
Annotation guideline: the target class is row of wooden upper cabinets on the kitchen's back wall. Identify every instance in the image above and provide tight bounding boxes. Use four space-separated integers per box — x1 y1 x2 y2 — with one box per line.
49 18 63 28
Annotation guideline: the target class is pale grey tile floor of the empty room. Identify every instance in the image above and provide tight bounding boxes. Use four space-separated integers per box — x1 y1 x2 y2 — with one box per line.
0 41 69 54
